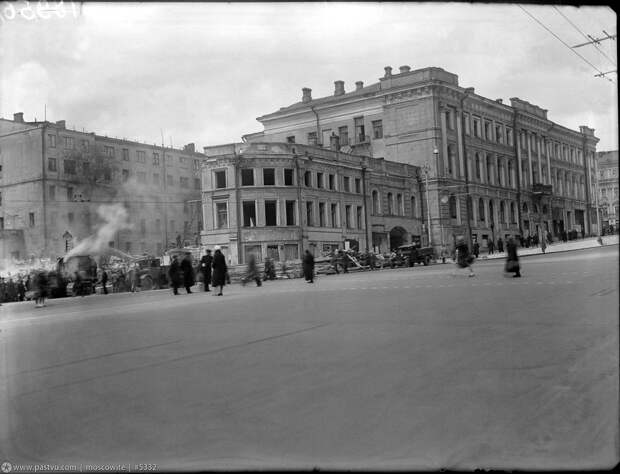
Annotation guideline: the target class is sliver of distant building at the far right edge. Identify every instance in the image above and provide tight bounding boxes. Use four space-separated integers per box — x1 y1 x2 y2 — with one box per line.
596 150 620 230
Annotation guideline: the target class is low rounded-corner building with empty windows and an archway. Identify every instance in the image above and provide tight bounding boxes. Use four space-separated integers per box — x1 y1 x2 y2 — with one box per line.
202 142 422 264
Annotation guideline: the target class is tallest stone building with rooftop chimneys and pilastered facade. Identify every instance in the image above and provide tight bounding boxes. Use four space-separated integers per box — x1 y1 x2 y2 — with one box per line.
244 66 598 252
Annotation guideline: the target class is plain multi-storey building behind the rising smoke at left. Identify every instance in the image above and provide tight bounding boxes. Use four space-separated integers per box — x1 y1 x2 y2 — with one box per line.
0 113 204 258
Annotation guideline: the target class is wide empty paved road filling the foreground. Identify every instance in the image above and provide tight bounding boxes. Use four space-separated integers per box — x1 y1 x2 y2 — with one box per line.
0 247 619 470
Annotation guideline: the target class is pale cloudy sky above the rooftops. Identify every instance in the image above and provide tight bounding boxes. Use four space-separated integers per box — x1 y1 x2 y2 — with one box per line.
0 2 618 150
